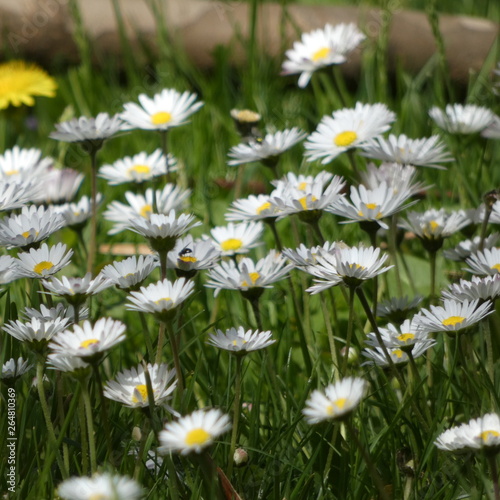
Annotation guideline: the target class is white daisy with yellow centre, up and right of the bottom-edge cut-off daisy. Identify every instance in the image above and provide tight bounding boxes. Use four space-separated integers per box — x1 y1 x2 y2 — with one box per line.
158 408 231 455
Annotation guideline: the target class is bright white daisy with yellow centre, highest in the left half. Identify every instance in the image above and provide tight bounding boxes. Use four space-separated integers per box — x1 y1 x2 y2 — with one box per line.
120 89 203 131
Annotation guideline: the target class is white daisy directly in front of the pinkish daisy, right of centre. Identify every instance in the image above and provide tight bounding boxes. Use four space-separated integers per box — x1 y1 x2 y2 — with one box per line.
326 181 416 229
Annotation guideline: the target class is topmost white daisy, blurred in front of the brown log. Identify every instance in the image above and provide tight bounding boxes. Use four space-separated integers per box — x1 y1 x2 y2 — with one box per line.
281 23 366 88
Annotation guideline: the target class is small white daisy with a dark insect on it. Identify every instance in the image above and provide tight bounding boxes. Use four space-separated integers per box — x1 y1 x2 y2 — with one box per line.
167 234 221 278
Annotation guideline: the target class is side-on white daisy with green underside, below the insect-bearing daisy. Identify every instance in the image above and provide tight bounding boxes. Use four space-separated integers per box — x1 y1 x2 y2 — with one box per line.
126 278 194 321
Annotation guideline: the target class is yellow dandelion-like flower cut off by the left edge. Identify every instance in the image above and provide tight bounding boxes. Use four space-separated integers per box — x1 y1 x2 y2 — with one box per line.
0 61 57 109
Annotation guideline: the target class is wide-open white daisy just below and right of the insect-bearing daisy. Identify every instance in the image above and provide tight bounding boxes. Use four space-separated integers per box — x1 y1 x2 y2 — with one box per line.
205 250 293 296
